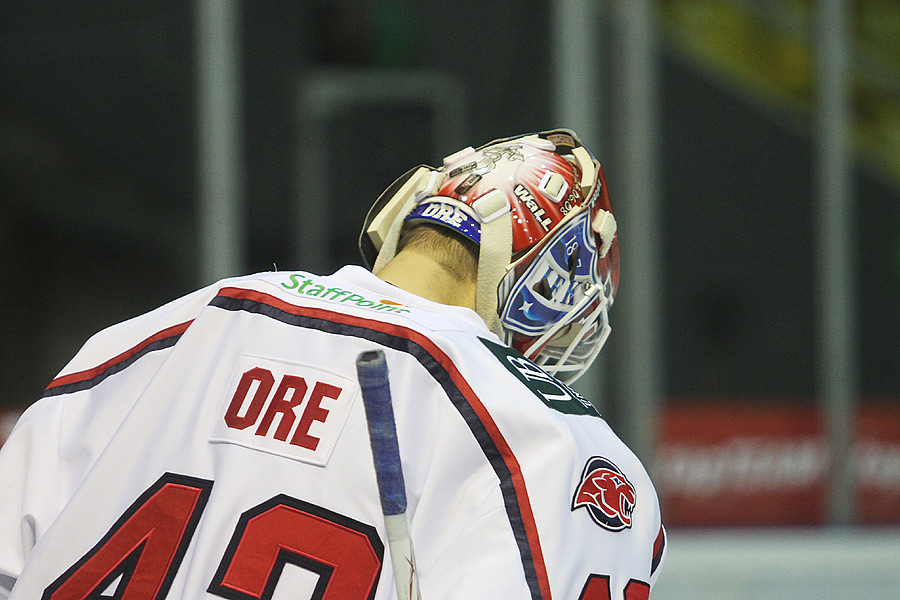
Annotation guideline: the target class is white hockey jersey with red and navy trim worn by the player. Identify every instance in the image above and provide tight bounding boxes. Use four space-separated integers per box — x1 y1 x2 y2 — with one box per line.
0 267 665 600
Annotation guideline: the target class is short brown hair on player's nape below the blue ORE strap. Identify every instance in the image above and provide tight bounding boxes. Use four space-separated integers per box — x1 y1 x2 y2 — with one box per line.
397 222 478 281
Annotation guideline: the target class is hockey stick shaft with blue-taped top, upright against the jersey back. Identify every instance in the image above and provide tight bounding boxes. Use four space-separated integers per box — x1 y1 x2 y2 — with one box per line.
356 350 419 600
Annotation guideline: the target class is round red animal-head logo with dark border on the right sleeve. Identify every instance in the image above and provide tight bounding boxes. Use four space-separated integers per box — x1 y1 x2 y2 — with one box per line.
572 456 636 531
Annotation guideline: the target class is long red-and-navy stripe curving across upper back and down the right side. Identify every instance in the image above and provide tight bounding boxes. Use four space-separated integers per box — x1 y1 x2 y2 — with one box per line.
210 288 550 600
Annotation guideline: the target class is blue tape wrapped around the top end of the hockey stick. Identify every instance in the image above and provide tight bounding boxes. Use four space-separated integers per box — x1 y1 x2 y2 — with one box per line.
356 350 406 515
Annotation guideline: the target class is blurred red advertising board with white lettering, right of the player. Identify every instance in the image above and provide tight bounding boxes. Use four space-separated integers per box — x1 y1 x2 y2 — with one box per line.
652 401 900 526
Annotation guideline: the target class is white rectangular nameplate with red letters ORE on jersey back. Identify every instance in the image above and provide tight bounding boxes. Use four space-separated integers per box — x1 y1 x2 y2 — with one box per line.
209 355 359 466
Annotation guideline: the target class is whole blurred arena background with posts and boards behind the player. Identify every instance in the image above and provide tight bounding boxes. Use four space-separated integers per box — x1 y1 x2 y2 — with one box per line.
0 0 900 600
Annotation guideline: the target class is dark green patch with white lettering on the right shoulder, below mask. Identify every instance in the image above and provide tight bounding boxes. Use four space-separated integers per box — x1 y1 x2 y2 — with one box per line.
478 338 600 417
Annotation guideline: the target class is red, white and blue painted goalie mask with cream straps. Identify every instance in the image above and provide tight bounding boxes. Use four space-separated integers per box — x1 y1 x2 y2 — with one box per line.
360 129 619 382
